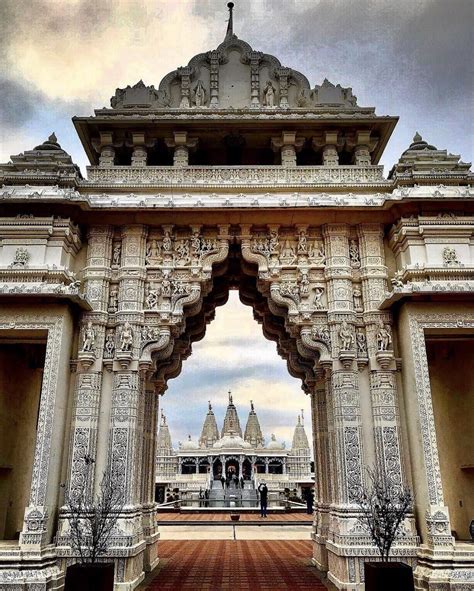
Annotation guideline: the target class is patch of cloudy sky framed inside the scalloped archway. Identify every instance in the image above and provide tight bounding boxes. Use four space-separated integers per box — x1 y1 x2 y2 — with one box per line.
160 291 311 454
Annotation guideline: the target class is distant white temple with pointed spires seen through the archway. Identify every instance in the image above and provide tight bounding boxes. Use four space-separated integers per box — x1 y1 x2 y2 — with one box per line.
156 392 314 507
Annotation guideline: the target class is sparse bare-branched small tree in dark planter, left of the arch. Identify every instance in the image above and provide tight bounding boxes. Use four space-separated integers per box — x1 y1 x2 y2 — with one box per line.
66 455 124 564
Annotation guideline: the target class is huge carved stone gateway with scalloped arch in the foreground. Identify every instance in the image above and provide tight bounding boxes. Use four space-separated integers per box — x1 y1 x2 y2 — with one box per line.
0 4 474 591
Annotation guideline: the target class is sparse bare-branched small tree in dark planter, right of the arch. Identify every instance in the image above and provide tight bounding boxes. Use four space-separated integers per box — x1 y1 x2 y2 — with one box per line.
356 469 413 562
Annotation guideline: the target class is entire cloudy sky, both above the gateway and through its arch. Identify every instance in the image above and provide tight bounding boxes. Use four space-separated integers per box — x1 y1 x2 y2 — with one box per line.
0 0 474 442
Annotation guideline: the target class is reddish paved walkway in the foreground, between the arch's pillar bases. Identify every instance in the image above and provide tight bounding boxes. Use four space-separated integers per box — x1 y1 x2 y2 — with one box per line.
140 540 326 591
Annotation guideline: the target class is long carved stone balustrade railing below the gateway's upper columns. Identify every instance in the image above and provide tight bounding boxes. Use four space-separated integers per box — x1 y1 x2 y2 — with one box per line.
87 166 389 189
